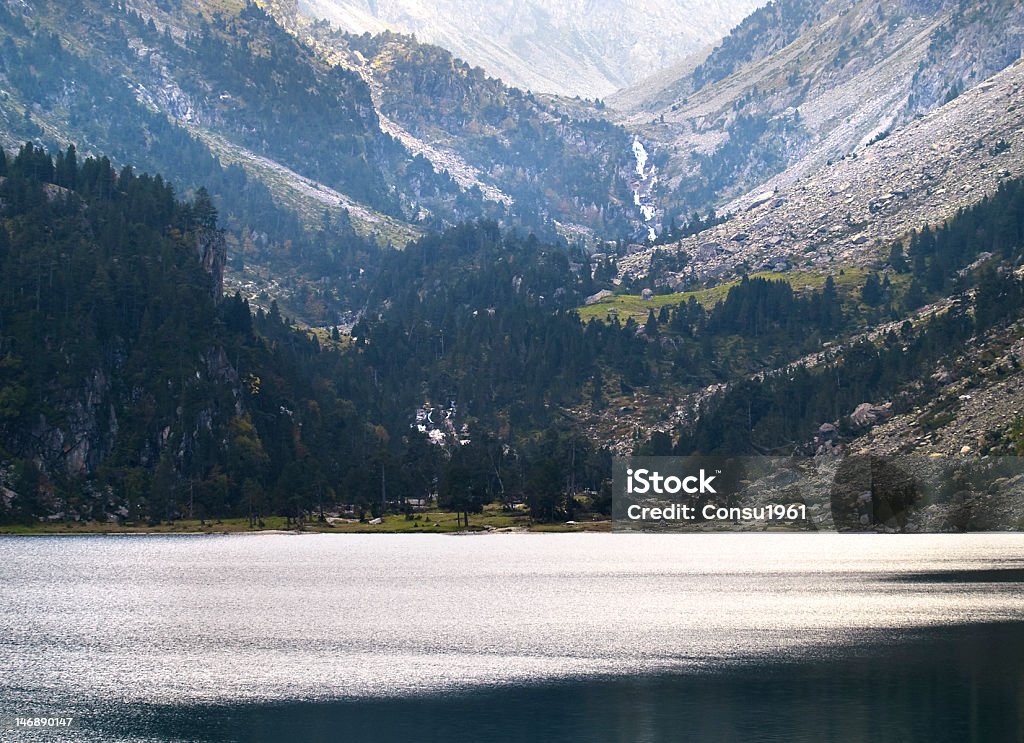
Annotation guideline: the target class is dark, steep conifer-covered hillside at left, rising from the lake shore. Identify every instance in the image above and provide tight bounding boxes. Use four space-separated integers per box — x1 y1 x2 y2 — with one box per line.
0 145 468 524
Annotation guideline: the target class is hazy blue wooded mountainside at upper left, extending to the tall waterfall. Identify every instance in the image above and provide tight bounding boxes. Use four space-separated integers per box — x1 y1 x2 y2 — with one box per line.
0 0 655 324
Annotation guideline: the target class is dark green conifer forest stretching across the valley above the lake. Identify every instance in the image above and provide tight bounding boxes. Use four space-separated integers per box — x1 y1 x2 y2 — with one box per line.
0 142 1024 523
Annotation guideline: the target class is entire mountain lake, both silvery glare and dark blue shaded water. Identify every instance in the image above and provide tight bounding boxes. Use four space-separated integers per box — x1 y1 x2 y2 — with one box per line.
0 534 1024 743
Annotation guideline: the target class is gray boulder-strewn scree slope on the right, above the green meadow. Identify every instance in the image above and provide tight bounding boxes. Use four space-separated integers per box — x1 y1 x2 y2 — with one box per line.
620 62 1024 286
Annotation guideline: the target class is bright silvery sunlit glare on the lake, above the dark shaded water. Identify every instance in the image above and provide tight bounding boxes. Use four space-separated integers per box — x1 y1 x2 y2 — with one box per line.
0 534 1024 703
